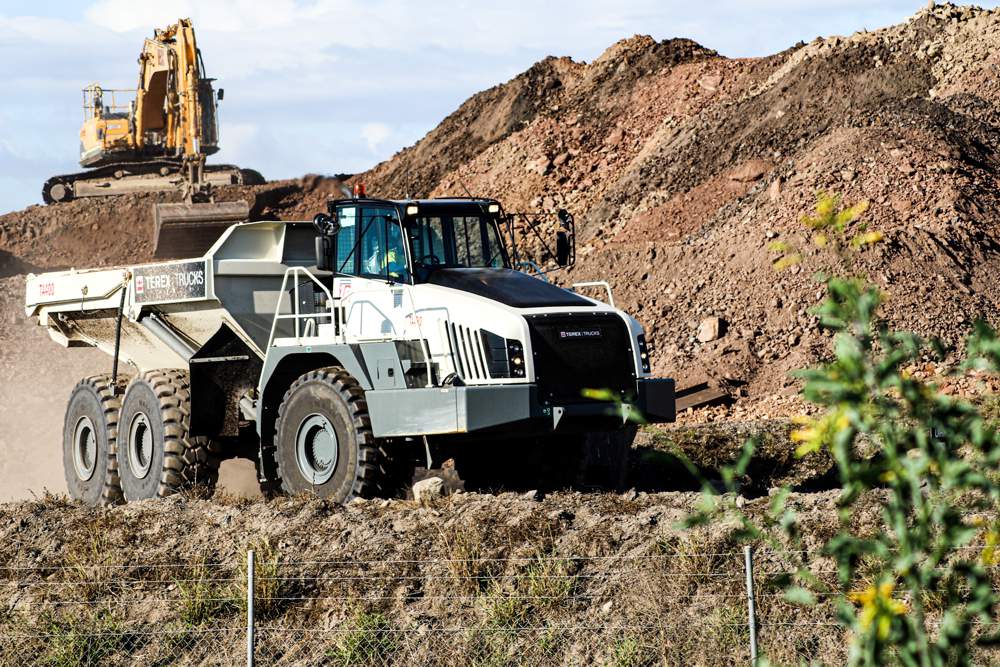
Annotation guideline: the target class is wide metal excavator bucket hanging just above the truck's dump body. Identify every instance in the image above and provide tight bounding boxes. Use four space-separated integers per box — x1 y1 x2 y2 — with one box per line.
153 200 250 259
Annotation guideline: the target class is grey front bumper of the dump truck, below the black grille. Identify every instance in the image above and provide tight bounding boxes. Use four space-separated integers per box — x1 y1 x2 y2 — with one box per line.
365 378 675 438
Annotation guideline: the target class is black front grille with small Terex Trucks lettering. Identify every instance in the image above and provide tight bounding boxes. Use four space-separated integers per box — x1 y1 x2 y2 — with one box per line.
525 313 635 404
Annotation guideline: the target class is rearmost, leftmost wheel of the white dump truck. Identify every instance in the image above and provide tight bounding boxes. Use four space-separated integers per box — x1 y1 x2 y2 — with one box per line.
63 375 122 506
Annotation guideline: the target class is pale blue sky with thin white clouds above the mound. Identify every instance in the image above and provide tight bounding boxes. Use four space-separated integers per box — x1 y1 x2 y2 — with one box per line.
0 0 1000 212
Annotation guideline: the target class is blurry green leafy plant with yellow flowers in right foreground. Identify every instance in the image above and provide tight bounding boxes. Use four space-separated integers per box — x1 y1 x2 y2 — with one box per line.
689 198 1000 667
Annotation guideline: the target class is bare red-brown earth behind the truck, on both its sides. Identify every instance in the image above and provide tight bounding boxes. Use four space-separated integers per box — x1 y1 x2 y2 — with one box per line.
0 5 1000 496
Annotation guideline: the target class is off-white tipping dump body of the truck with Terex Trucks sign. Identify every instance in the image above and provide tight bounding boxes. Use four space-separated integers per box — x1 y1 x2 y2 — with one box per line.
26 223 298 371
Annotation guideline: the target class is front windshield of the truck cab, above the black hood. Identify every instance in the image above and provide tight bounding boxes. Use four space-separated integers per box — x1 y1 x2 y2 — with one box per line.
406 211 507 275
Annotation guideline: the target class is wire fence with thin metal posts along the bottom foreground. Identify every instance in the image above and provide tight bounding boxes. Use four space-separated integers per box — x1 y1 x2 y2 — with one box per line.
0 551 995 667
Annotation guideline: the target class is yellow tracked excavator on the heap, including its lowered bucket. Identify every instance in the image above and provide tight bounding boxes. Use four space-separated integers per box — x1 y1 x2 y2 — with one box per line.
42 19 264 257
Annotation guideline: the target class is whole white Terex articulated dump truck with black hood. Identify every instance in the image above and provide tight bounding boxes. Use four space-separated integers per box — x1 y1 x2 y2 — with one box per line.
26 199 674 504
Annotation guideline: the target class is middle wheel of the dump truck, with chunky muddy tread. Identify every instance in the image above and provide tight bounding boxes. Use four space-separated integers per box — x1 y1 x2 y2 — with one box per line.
118 370 220 501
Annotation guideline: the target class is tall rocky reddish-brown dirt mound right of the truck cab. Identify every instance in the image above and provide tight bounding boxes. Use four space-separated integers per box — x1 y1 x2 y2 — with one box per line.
406 5 1000 397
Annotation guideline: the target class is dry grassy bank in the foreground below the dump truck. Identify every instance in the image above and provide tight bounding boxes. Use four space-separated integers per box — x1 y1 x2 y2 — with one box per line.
0 494 1000 666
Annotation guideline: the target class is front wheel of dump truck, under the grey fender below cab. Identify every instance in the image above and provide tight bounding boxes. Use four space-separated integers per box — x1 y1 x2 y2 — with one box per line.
275 366 388 503
